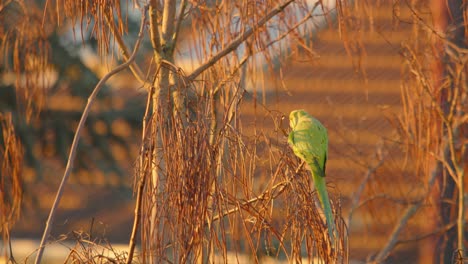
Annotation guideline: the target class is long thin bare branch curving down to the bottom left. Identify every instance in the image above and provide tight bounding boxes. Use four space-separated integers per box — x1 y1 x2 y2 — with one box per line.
35 7 147 264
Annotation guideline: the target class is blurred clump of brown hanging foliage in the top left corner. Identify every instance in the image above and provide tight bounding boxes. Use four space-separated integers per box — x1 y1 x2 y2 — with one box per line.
0 1 51 121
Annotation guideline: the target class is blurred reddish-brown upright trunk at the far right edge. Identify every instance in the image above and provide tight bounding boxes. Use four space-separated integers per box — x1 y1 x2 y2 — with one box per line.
420 0 466 263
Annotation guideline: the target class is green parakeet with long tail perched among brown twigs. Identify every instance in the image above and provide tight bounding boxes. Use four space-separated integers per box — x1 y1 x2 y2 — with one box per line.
288 110 338 244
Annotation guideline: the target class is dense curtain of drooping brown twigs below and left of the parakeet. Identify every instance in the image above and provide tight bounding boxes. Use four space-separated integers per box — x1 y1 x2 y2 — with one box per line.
136 72 346 263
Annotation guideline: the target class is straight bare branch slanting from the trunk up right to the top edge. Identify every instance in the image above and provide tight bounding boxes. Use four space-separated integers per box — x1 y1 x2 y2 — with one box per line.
187 0 294 81
